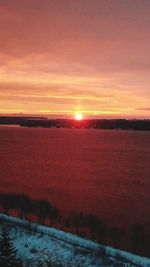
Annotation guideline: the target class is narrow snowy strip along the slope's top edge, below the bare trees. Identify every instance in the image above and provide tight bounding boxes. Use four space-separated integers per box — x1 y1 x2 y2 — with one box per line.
0 214 150 267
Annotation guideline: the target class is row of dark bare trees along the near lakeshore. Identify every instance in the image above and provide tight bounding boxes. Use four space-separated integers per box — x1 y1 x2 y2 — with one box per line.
0 193 150 257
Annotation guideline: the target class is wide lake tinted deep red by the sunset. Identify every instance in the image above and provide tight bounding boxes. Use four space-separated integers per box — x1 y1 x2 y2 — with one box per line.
0 126 150 229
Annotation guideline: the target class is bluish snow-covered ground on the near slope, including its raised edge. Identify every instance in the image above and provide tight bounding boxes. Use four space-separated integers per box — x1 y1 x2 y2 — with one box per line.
0 214 150 267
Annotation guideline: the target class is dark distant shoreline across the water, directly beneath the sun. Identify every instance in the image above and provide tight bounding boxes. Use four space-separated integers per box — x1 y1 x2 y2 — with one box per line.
0 116 150 131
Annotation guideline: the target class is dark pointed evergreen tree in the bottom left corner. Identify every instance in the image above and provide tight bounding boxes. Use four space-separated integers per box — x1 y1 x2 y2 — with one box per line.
0 227 23 267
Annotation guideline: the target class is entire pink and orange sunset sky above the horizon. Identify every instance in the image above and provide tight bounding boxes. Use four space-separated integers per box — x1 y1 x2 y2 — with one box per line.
0 0 150 118
